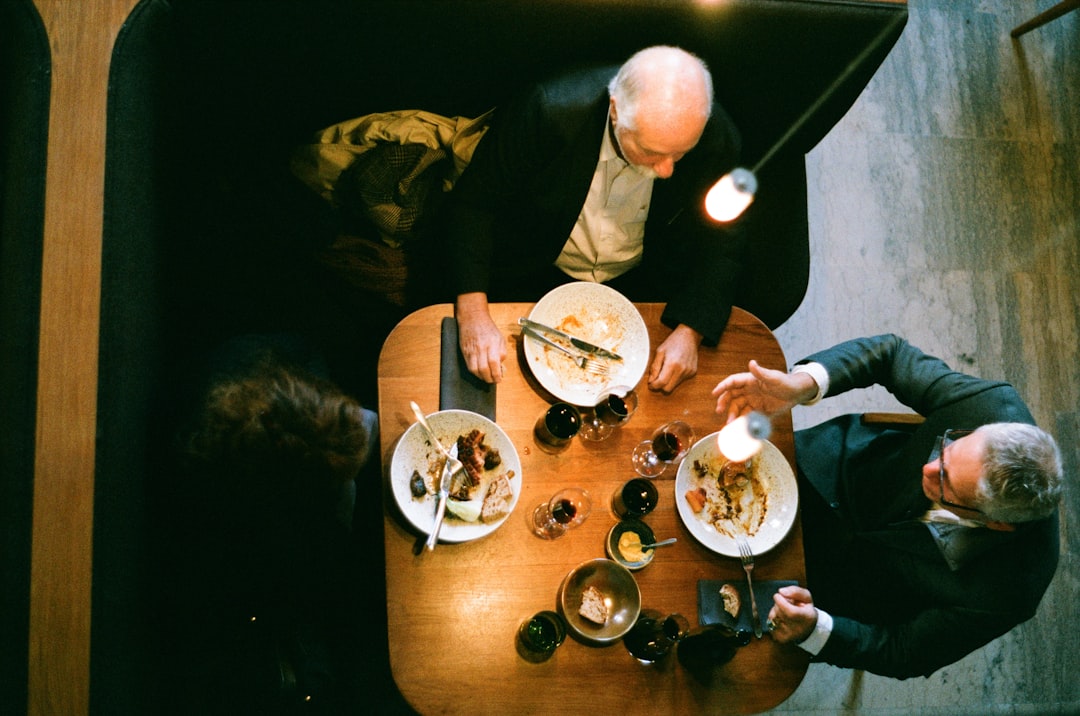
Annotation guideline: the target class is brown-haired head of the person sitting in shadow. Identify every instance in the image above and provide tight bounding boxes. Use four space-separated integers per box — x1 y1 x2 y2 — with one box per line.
180 338 378 530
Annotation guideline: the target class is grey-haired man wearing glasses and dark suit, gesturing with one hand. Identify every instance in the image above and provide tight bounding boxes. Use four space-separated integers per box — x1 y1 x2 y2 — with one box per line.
713 335 1062 678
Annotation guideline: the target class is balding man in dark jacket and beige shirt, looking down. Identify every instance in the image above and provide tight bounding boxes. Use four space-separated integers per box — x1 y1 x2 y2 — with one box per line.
445 45 744 392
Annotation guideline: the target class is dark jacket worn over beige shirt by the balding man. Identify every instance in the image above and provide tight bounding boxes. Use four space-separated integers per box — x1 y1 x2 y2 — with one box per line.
444 67 742 343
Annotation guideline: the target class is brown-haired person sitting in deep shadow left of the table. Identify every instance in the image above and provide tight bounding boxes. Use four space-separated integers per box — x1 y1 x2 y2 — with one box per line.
157 335 378 713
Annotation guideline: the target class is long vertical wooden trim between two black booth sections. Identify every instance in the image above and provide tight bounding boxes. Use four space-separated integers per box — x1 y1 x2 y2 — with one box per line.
28 0 135 715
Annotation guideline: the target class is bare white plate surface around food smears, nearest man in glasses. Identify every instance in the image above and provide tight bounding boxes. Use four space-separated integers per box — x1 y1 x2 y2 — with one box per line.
675 433 799 557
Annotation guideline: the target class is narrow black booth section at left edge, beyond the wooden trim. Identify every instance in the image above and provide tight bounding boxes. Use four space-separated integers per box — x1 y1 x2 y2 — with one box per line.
0 0 51 714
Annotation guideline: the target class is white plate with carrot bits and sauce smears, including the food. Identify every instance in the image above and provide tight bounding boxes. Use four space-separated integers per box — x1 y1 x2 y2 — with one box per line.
675 433 799 557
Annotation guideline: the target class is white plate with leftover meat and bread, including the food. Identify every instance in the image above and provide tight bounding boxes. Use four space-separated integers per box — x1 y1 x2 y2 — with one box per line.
390 410 522 542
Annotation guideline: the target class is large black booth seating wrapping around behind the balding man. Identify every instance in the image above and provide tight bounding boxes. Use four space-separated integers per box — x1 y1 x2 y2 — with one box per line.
97 0 905 714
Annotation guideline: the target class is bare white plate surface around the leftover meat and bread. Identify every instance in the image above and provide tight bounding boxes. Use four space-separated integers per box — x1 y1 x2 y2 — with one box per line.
390 410 522 542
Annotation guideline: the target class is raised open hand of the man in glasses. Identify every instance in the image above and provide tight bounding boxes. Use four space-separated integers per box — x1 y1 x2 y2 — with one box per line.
713 361 818 421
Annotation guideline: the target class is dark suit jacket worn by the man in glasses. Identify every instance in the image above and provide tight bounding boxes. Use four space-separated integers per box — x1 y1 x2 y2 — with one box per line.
796 336 1058 678
